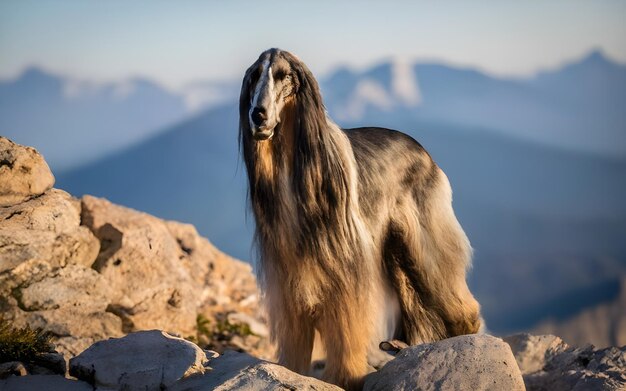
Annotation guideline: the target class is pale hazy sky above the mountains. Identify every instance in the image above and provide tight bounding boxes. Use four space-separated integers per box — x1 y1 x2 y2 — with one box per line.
0 0 626 89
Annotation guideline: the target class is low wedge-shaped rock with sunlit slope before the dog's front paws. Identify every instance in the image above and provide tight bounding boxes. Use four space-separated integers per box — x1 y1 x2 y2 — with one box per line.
171 351 341 391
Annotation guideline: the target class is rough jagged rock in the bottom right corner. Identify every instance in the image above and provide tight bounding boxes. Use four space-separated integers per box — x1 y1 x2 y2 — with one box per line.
505 334 626 391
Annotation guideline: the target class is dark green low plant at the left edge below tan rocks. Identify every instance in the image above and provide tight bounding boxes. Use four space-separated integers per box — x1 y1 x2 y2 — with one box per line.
0 319 54 362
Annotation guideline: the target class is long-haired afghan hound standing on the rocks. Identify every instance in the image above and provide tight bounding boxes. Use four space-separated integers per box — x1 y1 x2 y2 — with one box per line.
239 49 480 389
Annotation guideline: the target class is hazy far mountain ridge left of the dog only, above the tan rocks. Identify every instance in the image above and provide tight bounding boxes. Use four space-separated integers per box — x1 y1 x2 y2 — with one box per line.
0 67 239 171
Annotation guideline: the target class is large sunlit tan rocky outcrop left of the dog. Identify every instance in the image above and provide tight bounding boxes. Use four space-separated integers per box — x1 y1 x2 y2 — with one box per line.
0 138 272 358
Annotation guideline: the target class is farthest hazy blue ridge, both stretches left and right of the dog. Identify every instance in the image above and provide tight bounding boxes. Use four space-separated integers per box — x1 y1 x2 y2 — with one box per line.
0 50 626 170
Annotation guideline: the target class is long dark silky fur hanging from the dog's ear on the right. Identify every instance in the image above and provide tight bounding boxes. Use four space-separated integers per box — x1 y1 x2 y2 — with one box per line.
290 57 355 270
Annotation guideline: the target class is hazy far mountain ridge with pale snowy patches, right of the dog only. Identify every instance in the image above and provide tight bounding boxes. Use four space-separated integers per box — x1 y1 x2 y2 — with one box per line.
322 51 626 157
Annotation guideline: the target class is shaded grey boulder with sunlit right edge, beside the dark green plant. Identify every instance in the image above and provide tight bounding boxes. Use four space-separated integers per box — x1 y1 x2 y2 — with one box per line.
70 330 208 389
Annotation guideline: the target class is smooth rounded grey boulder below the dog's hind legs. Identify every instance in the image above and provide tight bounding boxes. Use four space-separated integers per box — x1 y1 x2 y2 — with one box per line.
363 335 524 391
